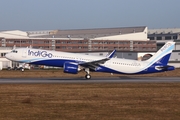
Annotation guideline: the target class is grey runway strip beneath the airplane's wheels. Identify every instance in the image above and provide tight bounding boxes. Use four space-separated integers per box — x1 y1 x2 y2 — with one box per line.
0 77 180 84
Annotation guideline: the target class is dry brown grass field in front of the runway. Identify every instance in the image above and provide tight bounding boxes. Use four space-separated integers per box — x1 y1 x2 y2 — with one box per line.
0 83 180 120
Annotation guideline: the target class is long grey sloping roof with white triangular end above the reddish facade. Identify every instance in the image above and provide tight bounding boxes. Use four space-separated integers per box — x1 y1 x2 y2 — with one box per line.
28 26 148 41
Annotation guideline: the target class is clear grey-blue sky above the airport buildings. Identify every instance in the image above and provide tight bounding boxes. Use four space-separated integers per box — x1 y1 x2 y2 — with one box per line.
0 0 180 31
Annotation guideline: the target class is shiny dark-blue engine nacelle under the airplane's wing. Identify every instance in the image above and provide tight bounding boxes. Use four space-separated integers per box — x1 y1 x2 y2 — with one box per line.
64 62 78 74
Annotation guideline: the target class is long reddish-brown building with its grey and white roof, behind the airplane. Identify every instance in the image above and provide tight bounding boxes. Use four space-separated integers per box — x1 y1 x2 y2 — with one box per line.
0 27 156 52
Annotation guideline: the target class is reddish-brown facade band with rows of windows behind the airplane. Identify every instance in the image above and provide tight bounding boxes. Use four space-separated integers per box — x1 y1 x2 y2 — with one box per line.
0 38 157 52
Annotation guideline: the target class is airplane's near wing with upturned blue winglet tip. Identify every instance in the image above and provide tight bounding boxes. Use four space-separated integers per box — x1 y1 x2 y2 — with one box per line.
79 50 116 70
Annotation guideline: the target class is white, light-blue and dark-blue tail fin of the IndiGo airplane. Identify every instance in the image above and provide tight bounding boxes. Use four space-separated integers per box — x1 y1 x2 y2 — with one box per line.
147 42 175 65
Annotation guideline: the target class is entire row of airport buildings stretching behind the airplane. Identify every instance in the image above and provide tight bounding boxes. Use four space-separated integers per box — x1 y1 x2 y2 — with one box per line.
0 26 180 68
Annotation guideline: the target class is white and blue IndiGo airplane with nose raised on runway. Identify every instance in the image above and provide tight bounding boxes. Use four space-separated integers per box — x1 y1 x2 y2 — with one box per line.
6 41 175 79
